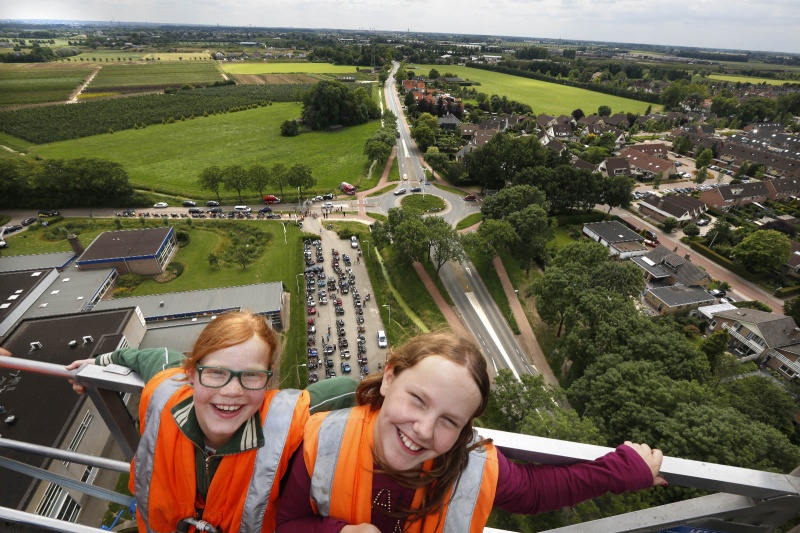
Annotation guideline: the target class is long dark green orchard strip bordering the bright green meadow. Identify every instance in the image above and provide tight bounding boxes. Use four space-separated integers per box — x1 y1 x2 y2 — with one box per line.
0 84 311 144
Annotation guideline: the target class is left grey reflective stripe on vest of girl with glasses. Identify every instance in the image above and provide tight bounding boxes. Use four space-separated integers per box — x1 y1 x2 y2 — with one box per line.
134 373 186 533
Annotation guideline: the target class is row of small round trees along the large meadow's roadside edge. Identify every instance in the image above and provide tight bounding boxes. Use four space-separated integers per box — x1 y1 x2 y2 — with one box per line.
197 163 317 202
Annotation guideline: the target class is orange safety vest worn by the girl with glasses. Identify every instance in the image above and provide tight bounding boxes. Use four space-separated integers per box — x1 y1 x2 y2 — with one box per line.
129 368 310 533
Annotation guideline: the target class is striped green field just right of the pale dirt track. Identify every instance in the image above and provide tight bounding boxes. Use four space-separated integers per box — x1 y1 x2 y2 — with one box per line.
84 61 223 94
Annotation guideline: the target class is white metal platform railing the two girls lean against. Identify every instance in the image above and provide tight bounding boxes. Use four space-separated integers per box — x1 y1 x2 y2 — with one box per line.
0 357 800 533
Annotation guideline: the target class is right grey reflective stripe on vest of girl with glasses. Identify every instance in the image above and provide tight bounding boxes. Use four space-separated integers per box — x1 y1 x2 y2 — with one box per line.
239 389 302 533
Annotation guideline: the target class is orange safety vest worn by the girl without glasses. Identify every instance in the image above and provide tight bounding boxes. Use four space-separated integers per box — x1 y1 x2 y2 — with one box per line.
303 405 499 533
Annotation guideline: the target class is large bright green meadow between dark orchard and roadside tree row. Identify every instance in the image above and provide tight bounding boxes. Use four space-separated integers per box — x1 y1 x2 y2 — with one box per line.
30 103 380 201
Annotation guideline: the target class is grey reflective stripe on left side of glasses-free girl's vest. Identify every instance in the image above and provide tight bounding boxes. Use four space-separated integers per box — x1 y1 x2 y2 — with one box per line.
311 409 351 516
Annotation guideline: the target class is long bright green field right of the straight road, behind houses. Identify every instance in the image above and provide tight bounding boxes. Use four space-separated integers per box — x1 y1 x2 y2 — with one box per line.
409 65 661 115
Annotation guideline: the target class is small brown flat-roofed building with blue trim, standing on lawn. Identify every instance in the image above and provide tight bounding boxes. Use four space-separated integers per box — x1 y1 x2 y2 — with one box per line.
76 226 177 276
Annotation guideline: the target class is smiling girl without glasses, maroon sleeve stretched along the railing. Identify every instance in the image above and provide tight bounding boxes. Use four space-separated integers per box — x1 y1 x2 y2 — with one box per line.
276 333 666 533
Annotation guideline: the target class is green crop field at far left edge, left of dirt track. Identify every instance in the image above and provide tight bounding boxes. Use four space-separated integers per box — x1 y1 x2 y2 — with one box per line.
0 63 93 106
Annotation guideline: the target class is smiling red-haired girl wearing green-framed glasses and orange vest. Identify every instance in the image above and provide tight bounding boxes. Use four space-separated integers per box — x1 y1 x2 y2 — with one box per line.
67 312 355 533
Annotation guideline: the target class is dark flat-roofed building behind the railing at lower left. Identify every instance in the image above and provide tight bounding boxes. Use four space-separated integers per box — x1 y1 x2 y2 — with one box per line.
0 308 145 522
